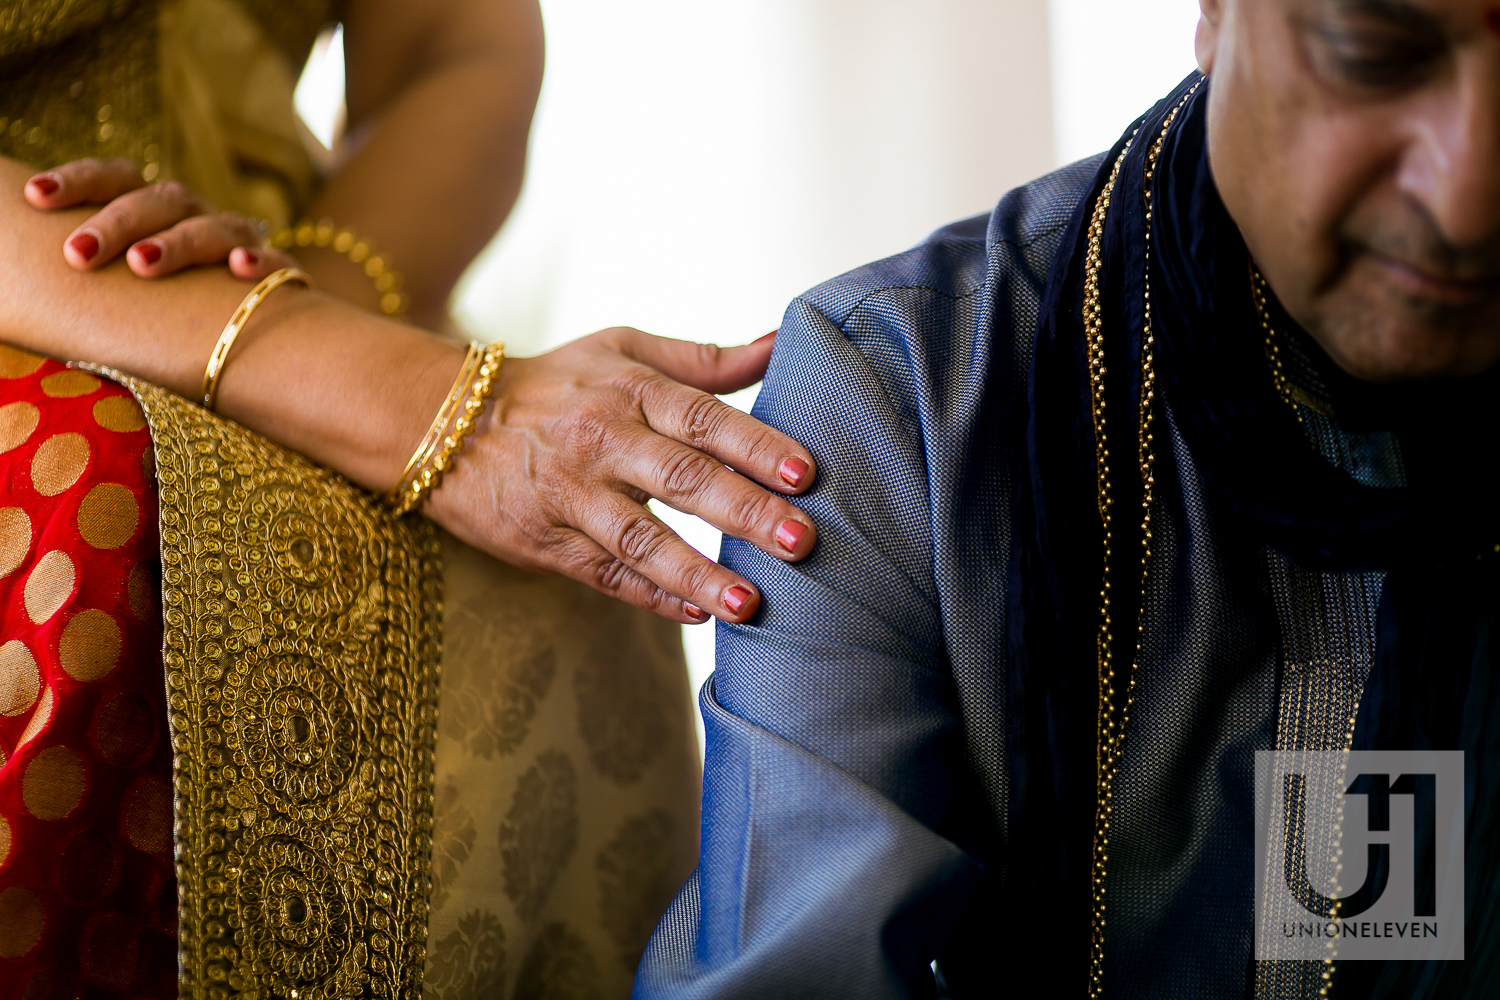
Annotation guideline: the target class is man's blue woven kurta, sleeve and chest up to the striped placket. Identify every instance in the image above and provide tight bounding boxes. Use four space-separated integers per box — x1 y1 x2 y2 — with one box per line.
636 157 1277 1000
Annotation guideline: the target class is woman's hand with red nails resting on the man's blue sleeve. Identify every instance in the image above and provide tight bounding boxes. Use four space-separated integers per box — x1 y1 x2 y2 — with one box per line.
428 328 816 624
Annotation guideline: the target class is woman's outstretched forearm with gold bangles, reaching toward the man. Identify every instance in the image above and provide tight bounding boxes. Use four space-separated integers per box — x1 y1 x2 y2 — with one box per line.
0 159 462 490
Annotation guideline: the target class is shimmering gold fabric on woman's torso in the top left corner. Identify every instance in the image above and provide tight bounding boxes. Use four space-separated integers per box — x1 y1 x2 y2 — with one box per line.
0 0 342 226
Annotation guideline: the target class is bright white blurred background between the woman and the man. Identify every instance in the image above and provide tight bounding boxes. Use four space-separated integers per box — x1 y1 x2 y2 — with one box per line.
299 0 1197 743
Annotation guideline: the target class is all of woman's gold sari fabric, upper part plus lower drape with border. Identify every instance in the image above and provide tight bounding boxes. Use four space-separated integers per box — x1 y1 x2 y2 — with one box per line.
0 0 701 1000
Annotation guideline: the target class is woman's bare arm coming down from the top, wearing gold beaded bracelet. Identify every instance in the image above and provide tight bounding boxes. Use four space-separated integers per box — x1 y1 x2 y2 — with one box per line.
299 0 543 325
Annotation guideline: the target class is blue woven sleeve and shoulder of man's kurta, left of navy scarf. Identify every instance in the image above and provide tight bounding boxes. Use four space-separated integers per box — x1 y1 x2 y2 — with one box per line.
636 159 1100 997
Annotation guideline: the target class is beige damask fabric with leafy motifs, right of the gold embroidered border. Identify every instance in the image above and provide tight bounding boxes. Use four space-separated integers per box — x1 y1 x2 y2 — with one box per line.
423 538 699 1000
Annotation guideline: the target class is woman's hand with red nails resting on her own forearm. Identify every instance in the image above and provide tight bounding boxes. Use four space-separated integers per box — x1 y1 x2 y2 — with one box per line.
26 159 297 282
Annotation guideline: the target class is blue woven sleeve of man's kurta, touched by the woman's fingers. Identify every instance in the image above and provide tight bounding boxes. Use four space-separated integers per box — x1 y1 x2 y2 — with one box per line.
636 293 983 1000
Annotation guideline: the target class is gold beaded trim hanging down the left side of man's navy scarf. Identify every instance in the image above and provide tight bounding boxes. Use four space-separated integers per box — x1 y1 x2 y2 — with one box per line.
1083 81 1202 1000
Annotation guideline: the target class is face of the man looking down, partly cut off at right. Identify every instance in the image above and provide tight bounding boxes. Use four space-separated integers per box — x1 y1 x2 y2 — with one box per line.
1199 0 1500 382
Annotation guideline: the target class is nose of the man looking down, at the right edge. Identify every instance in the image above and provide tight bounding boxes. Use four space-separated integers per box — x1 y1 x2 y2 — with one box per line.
1401 66 1500 247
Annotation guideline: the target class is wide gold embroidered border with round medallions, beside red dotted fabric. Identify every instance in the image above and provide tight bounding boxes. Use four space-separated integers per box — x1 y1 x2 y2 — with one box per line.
102 370 441 1000
